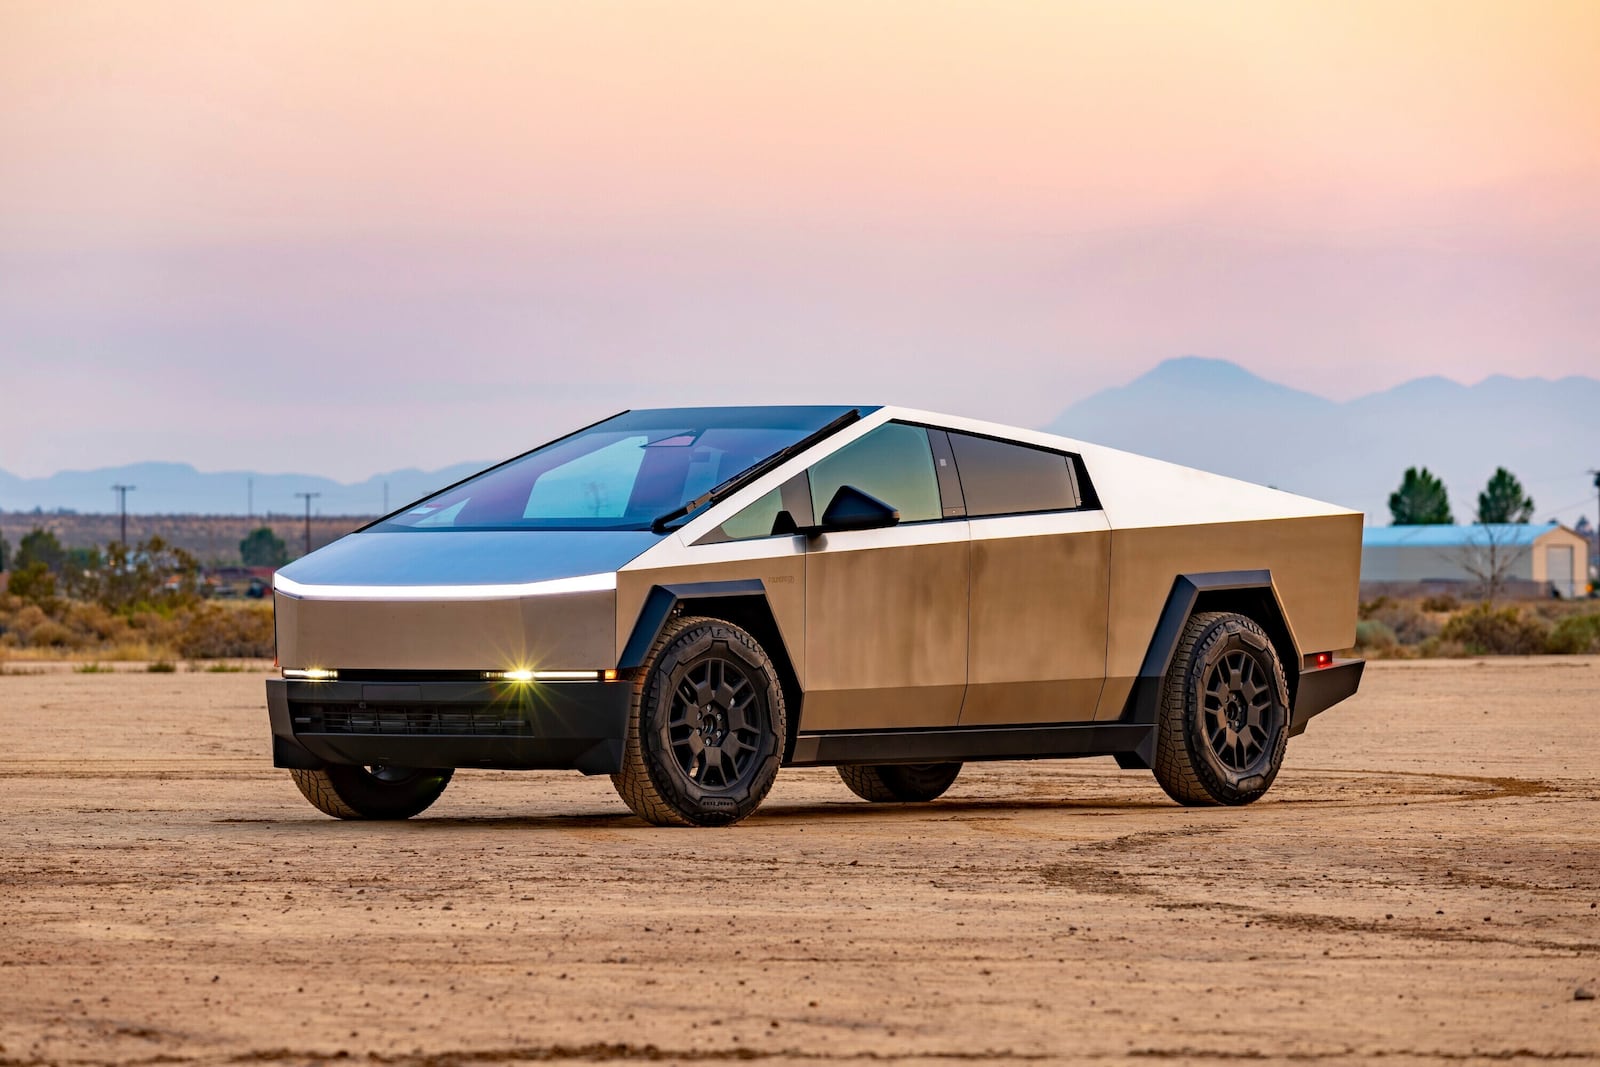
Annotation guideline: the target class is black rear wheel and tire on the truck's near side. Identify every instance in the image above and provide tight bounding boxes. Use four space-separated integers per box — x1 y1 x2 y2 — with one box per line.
1155 611 1290 806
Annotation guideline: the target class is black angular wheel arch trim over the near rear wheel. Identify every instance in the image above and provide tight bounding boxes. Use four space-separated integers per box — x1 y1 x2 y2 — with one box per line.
1123 569 1301 723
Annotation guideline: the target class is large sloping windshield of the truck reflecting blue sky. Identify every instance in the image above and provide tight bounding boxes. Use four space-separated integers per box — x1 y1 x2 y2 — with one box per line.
371 408 850 530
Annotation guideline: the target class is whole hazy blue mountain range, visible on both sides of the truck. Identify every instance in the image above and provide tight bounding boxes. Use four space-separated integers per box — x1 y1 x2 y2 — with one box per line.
0 357 1600 525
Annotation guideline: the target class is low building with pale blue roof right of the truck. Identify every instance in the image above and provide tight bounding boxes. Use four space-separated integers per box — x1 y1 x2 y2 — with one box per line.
1362 523 1589 597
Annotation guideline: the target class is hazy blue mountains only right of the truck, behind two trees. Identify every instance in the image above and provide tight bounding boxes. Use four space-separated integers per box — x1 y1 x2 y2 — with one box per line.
1045 357 1600 525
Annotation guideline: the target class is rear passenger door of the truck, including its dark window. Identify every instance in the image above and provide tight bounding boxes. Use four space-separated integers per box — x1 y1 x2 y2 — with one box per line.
933 430 1110 726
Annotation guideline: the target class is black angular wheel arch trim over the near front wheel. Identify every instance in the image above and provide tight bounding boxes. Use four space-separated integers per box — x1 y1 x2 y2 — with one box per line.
618 577 805 763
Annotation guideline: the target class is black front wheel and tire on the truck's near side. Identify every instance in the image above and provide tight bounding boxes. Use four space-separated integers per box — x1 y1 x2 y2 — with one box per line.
611 616 787 825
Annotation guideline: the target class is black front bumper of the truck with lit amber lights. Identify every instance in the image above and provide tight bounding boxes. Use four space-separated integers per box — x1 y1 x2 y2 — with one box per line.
267 677 632 774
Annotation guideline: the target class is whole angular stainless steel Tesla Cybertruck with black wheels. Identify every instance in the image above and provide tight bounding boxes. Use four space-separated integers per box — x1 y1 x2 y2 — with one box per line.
267 406 1363 825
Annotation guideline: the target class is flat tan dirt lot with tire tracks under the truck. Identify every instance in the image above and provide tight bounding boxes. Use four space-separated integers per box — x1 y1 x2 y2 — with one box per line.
0 659 1600 1064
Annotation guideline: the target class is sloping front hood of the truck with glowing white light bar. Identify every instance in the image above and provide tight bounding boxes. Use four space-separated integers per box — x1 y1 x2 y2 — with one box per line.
277 530 661 598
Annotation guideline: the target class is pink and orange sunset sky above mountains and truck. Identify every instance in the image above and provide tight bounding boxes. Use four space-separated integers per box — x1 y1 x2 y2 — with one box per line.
0 0 1600 478
